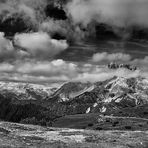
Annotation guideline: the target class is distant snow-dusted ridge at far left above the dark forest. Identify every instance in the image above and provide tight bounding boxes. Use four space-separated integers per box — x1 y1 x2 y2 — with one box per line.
0 82 55 100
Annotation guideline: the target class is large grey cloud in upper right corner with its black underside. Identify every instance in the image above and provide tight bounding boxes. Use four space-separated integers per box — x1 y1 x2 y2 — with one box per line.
67 0 148 40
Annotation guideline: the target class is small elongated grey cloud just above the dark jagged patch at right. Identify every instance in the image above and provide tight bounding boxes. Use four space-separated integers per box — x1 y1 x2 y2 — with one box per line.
92 52 131 62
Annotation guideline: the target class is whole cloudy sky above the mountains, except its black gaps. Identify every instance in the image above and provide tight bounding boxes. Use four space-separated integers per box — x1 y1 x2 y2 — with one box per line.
0 0 148 84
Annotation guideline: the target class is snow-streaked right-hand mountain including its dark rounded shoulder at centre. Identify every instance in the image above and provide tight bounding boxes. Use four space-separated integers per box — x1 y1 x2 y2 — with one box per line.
54 77 148 117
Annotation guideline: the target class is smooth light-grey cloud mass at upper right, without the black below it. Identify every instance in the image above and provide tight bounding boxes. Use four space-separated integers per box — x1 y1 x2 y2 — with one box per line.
67 0 148 27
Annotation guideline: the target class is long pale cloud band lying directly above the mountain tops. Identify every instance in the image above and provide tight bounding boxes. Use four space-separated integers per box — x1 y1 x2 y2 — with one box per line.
0 59 148 83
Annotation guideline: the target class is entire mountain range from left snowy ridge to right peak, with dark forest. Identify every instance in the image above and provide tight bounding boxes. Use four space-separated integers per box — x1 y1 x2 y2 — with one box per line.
0 77 148 127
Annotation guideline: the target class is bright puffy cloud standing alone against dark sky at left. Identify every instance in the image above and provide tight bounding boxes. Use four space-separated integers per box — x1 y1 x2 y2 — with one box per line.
14 32 68 58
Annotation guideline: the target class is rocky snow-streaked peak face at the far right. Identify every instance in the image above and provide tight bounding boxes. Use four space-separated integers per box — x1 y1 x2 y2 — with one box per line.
95 77 148 112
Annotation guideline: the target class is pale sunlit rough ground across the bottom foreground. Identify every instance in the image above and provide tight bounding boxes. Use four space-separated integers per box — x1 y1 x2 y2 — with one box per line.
0 122 148 148
